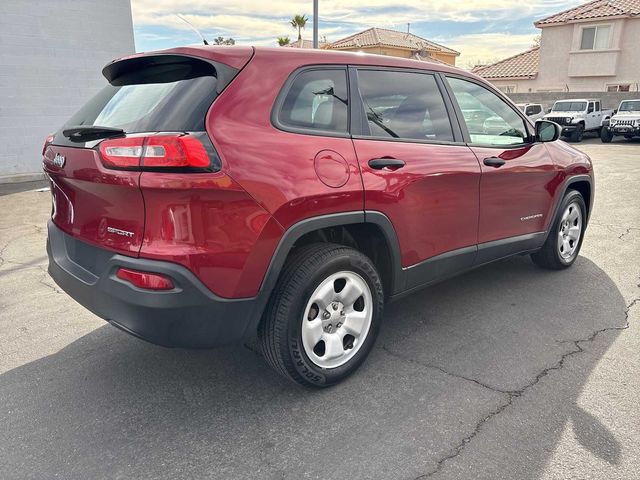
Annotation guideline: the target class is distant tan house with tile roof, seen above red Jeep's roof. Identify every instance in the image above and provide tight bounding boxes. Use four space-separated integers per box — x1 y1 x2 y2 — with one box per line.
324 27 460 65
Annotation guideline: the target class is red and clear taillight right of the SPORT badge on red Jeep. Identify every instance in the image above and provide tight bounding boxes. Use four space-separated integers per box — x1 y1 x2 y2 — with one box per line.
99 134 211 169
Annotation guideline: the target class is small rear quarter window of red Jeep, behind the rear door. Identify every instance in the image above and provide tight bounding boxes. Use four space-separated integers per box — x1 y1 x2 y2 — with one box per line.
278 69 348 133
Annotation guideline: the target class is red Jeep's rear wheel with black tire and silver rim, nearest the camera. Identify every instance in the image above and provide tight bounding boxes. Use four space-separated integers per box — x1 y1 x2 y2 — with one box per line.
258 243 384 387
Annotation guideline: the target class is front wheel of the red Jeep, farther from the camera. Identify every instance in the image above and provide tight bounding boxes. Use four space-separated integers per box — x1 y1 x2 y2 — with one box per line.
531 190 587 270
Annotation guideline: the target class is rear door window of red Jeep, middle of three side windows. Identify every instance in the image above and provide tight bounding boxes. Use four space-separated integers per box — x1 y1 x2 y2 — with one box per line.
358 70 453 141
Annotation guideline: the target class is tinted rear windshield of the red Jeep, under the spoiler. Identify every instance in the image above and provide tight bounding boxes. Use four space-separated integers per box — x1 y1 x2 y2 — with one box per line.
56 61 217 145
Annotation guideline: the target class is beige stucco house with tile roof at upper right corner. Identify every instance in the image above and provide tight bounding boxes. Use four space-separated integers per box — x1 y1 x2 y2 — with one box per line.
473 0 640 93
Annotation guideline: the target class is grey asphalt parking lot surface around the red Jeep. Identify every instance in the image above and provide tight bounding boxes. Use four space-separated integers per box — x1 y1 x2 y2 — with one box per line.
0 138 640 480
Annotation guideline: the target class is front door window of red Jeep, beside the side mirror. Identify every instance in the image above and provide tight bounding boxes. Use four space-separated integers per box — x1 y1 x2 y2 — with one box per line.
447 78 529 146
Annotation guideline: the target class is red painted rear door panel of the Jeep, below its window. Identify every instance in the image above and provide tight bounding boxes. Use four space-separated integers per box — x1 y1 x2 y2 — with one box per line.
354 140 480 267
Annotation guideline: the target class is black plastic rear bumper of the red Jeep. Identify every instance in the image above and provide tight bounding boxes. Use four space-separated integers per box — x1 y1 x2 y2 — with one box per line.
47 220 260 348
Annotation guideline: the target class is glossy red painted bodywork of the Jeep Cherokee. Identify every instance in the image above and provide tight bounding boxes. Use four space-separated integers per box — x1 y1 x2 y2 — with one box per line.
44 47 591 298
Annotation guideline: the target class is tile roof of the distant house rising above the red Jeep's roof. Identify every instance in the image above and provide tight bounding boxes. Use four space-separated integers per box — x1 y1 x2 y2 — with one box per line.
329 27 460 55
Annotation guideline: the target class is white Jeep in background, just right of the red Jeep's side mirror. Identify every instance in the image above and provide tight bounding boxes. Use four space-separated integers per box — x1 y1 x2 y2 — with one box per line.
543 98 613 142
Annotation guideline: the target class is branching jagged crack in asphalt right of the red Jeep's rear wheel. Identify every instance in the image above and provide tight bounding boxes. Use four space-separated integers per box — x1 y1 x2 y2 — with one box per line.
382 297 640 480
